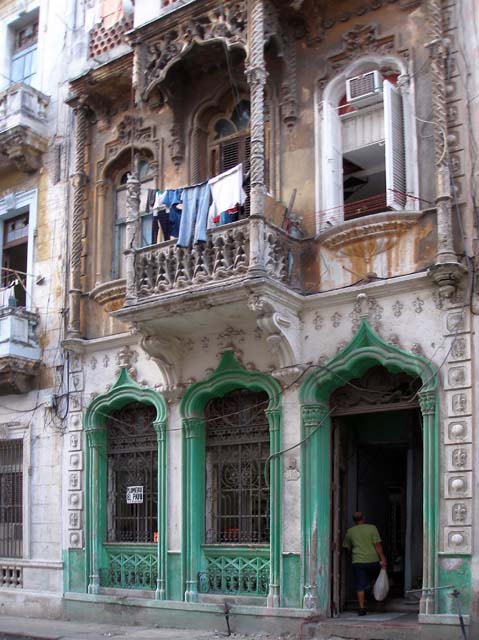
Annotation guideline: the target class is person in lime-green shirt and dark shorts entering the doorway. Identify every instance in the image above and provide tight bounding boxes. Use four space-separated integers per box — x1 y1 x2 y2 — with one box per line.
343 511 388 616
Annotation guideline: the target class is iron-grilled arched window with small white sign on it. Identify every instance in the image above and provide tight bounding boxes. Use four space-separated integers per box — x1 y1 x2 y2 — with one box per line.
106 402 158 542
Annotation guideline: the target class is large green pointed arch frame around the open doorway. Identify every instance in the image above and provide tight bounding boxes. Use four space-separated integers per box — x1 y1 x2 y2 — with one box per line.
299 318 439 613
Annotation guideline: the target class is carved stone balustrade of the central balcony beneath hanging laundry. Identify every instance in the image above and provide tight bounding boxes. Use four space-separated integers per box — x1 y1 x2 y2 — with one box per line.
135 219 293 300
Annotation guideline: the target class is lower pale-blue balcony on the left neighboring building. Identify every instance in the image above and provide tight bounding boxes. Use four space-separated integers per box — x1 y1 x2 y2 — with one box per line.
0 307 40 395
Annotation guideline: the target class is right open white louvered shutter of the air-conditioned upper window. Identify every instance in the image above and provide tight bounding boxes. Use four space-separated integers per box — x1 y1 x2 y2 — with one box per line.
383 80 406 209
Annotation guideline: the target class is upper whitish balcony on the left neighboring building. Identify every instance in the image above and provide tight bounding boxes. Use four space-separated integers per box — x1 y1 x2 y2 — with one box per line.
0 82 50 173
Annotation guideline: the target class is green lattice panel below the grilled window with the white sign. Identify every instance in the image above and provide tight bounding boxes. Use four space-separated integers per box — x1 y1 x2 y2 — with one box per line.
100 553 158 590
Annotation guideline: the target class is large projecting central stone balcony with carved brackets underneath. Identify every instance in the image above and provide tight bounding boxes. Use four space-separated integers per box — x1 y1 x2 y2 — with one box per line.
112 218 302 361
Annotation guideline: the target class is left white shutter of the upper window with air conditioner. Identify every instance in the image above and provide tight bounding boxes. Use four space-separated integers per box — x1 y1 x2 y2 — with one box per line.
322 102 344 217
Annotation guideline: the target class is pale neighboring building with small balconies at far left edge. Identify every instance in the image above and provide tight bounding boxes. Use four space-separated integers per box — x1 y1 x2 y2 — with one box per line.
0 1 72 615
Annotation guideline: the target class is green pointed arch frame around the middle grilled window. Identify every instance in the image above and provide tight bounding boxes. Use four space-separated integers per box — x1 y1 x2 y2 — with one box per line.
180 351 281 607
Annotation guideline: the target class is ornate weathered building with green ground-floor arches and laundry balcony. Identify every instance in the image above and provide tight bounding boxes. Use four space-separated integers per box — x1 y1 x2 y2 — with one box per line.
0 0 479 638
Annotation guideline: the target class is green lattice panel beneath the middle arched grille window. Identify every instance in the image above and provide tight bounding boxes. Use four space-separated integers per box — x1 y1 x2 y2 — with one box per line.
198 556 270 596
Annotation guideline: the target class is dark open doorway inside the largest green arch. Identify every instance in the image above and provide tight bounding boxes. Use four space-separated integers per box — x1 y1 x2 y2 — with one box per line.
329 365 423 616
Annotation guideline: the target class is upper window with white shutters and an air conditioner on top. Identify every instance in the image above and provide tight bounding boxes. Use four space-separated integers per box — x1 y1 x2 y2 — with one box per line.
321 64 411 224
